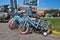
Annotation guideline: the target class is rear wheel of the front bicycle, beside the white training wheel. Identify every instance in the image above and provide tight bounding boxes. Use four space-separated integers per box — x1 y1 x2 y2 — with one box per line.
40 23 52 34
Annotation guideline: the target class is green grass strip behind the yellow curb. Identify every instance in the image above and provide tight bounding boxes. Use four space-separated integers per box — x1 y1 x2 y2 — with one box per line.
42 18 60 32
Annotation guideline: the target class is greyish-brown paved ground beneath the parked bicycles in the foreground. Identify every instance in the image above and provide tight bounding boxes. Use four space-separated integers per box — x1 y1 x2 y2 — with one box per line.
0 23 60 40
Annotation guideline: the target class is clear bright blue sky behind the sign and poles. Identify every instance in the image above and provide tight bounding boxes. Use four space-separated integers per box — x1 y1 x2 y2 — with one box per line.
0 0 60 10
